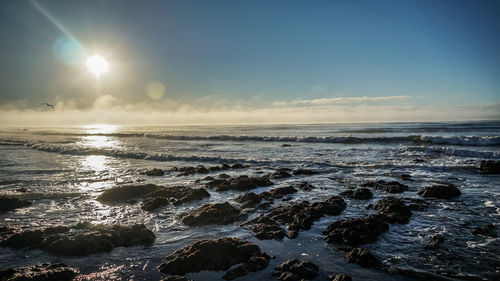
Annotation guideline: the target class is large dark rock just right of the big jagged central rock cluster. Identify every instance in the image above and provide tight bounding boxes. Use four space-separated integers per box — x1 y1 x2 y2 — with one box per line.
323 215 389 249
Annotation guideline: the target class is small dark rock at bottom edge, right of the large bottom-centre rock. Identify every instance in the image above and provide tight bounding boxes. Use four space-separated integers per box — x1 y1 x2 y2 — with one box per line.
273 259 319 281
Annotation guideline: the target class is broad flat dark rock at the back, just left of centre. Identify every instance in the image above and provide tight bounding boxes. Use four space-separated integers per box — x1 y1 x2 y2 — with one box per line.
207 175 273 191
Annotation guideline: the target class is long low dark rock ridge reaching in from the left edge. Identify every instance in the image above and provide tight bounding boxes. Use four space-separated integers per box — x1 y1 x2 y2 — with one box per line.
0 222 156 256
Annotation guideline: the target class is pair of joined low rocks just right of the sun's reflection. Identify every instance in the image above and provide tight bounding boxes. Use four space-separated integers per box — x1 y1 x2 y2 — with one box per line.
97 184 210 211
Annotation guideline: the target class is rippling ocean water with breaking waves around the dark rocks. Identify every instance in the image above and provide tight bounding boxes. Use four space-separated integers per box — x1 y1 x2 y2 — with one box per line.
0 121 500 280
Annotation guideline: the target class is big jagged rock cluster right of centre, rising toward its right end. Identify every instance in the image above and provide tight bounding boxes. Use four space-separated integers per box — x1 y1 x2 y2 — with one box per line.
243 196 346 241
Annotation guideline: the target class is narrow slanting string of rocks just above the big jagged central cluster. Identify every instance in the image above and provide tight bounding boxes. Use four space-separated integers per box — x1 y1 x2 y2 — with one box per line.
235 182 314 208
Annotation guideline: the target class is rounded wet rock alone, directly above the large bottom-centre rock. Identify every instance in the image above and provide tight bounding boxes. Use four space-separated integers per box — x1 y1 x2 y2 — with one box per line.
182 202 245 226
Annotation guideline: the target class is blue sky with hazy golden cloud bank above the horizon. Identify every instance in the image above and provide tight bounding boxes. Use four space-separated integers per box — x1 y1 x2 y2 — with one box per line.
0 0 500 125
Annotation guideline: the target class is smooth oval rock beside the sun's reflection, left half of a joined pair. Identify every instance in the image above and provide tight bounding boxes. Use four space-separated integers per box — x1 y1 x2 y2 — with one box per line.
97 184 161 203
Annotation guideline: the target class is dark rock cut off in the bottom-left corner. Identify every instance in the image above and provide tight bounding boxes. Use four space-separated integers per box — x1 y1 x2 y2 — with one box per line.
0 263 79 281
